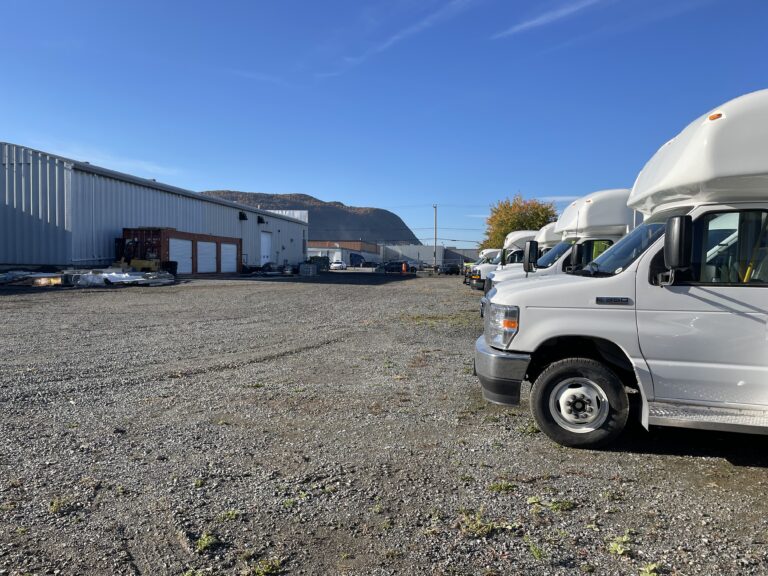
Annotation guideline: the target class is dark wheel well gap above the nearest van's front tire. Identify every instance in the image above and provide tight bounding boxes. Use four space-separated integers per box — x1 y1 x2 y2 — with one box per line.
526 336 639 396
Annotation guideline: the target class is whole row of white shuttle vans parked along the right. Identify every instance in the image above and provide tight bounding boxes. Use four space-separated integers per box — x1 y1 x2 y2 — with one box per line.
473 90 768 446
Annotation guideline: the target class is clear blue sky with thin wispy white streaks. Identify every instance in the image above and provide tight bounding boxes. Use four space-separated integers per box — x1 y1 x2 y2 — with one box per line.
0 0 768 246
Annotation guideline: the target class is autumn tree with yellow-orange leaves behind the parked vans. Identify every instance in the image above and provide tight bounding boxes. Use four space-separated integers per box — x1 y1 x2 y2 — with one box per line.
480 194 557 250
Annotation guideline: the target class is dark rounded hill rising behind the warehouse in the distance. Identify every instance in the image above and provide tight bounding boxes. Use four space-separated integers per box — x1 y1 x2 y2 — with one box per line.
203 190 421 244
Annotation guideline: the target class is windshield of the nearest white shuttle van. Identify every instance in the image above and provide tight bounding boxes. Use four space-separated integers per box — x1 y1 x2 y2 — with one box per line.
576 206 691 276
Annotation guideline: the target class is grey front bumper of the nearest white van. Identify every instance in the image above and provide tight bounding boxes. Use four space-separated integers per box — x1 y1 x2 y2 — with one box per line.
475 336 531 406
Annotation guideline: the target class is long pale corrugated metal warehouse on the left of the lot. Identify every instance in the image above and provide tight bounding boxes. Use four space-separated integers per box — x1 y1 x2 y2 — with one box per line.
0 143 308 272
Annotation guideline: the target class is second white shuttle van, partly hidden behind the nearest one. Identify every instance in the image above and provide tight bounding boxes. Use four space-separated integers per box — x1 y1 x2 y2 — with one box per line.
484 188 636 294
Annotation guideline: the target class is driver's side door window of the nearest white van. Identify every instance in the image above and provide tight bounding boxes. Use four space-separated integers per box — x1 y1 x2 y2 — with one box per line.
690 210 768 286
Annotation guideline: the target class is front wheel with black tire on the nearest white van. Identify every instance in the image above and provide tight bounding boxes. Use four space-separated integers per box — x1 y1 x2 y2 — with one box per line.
531 358 629 448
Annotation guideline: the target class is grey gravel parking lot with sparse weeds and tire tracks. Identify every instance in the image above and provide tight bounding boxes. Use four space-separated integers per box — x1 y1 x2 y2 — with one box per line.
0 273 768 575
